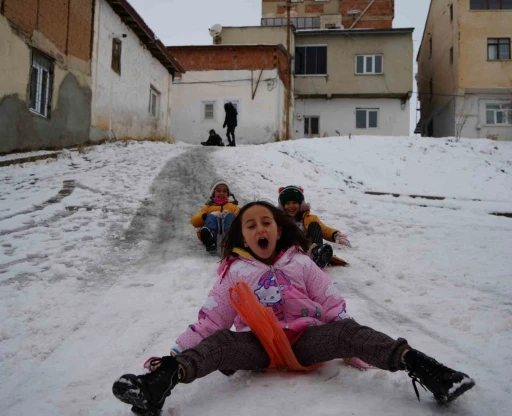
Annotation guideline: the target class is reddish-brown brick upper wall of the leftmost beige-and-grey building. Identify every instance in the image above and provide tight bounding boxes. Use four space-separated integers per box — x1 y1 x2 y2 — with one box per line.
3 0 94 61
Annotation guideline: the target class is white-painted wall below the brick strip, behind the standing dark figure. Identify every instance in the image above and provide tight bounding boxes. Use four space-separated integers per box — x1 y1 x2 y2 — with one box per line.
171 70 285 145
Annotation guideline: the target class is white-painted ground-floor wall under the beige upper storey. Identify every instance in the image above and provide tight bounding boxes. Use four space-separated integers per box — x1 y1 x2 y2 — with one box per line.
294 98 410 139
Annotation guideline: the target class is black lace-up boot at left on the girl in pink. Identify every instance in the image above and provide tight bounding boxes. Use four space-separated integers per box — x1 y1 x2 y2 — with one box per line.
112 356 180 416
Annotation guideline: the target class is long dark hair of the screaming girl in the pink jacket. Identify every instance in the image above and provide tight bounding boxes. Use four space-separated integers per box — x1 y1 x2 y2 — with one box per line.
222 201 311 260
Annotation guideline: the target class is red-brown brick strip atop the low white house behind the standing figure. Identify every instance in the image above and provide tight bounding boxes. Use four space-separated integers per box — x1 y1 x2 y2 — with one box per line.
167 45 288 86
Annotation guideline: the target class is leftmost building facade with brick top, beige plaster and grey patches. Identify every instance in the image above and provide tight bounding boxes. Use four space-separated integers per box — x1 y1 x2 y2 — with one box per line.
0 0 93 153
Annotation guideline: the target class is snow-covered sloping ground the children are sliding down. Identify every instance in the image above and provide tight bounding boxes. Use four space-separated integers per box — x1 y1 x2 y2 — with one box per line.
0 137 512 416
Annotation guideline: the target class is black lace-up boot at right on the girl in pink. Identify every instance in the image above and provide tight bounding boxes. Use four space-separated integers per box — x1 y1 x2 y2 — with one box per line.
404 349 475 404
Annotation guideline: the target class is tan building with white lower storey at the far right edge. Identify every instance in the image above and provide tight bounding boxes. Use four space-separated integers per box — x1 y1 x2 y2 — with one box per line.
416 0 512 140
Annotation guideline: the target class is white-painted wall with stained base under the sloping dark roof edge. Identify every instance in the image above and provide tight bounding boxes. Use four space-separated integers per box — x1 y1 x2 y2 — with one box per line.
91 0 172 140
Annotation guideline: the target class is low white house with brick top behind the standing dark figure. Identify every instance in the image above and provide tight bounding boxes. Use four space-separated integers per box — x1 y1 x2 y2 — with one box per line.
168 45 293 145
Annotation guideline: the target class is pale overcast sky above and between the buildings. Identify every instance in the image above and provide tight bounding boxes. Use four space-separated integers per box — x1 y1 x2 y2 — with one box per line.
130 0 430 133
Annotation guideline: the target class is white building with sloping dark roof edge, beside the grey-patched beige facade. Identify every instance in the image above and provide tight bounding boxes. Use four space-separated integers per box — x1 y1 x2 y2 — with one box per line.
91 0 183 141
